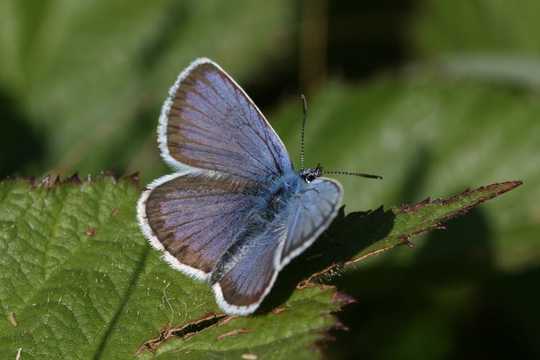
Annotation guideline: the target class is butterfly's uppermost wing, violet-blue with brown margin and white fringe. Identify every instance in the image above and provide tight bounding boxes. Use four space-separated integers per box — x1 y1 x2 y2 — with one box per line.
158 59 291 181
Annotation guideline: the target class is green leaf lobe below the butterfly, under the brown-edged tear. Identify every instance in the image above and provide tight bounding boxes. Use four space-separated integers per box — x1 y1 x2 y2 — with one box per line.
139 287 341 359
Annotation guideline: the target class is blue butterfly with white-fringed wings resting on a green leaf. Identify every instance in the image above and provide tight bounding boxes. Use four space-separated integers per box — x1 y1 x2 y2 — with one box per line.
137 58 374 315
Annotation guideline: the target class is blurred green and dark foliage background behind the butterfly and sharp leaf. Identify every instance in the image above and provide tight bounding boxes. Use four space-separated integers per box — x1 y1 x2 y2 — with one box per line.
0 0 540 359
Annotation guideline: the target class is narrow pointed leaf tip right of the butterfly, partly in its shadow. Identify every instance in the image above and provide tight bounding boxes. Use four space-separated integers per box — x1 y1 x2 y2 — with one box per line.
302 181 522 283
